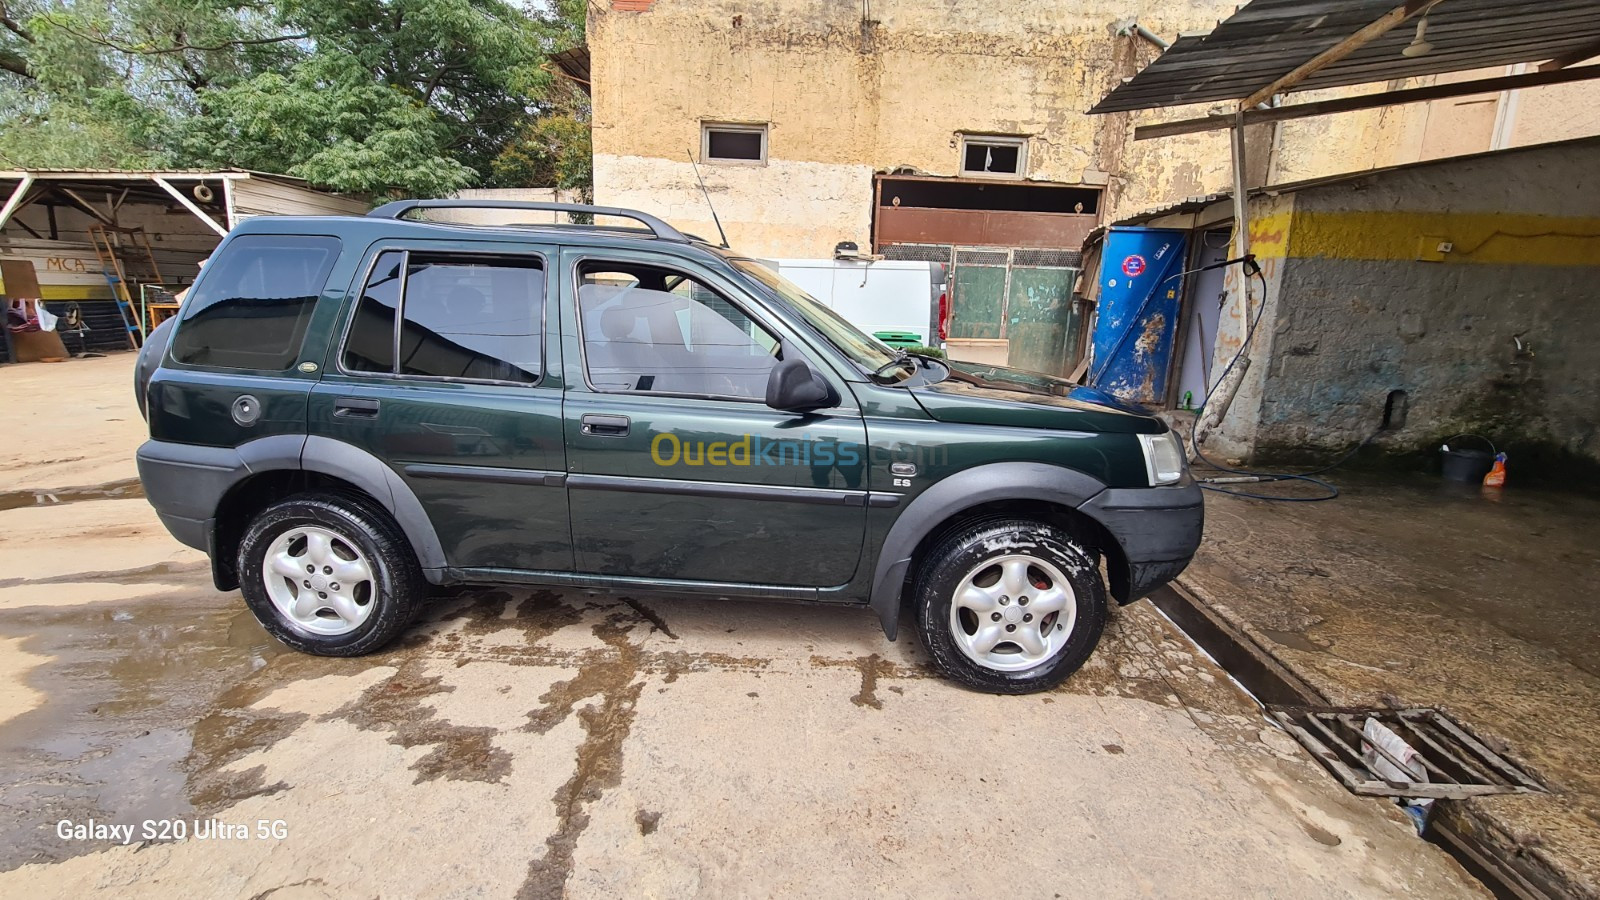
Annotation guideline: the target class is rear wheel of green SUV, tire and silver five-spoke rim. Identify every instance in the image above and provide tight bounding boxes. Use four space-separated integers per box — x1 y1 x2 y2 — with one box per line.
238 493 427 657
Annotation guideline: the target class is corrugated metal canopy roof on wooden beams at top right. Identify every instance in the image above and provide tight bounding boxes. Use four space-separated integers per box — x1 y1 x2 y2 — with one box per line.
1090 0 1600 112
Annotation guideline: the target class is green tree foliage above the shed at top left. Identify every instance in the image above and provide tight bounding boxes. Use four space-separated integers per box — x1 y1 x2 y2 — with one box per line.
0 0 590 195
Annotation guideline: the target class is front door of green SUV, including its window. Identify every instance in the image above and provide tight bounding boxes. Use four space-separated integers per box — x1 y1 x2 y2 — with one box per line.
562 251 867 588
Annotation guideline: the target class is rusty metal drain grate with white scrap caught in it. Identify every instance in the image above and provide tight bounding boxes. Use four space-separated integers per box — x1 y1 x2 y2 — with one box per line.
1267 706 1544 801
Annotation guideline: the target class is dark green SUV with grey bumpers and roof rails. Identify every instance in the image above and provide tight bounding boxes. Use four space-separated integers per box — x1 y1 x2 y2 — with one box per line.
138 200 1203 693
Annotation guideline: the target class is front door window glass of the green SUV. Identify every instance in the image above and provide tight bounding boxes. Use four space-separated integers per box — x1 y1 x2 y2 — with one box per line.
578 263 779 400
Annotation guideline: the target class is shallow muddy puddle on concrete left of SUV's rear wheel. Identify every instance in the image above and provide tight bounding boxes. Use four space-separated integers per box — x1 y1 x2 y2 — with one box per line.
0 585 283 871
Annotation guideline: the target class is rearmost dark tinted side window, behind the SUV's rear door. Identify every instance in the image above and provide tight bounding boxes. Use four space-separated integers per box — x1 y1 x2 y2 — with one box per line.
173 234 339 372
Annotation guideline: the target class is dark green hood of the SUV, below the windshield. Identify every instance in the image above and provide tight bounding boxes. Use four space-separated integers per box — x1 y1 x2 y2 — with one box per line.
910 360 1166 434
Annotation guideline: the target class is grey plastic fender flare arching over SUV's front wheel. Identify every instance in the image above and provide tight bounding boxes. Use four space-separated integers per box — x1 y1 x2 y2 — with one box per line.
870 463 1106 641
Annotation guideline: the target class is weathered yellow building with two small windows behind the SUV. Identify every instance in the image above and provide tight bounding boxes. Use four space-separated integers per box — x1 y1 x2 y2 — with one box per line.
589 0 1260 370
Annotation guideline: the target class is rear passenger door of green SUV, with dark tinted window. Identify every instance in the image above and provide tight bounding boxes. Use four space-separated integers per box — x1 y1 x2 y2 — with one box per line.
310 242 573 572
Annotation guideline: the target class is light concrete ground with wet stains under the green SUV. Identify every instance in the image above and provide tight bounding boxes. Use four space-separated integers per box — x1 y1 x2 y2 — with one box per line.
0 357 1482 900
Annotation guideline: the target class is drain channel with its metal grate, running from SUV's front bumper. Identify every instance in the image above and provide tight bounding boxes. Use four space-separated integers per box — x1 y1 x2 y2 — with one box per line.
1150 585 1578 900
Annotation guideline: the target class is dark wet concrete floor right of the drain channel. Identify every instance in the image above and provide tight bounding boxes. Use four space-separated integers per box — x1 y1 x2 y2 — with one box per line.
1181 464 1600 895
